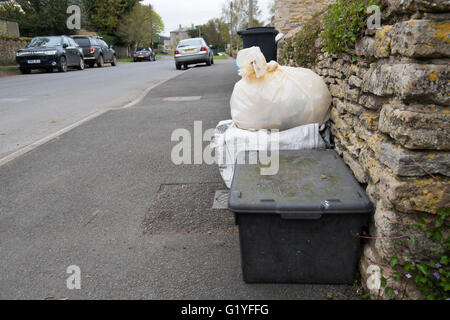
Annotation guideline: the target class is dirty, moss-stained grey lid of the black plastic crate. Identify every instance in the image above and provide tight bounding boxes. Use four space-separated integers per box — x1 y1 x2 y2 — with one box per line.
228 150 372 219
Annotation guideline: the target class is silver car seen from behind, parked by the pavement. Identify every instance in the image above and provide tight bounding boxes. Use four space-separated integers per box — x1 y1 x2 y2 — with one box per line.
175 38 214 70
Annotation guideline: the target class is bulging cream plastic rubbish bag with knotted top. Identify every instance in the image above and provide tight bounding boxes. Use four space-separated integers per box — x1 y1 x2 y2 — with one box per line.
230 47 331 130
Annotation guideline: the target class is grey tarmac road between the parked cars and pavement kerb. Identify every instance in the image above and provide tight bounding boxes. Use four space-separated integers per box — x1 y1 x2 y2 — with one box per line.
0 57 180 162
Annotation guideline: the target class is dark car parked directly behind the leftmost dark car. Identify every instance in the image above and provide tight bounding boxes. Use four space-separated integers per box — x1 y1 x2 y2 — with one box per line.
72 36 117 68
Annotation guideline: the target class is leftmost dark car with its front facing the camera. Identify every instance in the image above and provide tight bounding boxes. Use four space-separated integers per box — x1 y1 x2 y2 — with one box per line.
16 36 84 74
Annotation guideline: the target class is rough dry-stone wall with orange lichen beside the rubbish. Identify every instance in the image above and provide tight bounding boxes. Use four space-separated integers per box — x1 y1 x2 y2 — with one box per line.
279 0 450 299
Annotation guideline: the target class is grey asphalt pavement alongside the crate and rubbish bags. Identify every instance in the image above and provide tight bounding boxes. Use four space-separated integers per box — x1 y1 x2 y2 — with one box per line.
0 61 358 299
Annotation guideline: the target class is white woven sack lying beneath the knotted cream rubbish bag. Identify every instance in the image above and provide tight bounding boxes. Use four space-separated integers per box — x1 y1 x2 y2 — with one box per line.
210 120 326 188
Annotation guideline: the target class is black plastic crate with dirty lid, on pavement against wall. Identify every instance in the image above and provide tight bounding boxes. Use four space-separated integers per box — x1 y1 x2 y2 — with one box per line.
228 150 373 284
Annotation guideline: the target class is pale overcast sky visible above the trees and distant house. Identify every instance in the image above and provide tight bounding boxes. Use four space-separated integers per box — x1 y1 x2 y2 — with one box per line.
144 0 273 36
